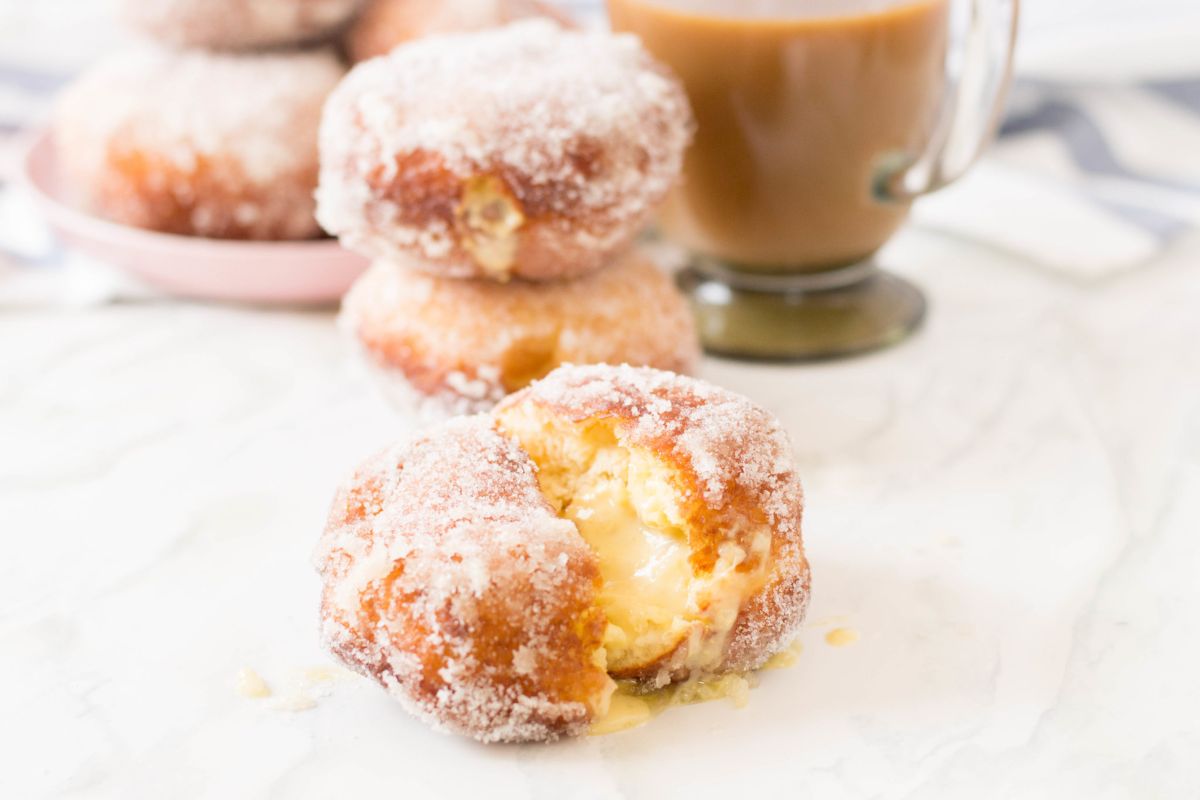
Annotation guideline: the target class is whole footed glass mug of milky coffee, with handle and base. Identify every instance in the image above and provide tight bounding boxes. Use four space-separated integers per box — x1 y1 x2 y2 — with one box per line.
608 0 1020 359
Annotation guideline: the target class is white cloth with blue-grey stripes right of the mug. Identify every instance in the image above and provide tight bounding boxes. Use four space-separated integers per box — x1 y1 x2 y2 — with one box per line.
913 71 1200 281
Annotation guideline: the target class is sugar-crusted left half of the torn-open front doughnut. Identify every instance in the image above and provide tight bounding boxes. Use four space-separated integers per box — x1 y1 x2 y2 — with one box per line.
314 417 611 741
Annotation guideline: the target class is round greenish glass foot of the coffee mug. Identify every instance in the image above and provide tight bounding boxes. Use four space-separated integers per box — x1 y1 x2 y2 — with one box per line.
677 258 926 361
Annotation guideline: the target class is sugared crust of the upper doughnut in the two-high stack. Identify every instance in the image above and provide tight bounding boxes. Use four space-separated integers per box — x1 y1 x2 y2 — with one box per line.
318 19 691 278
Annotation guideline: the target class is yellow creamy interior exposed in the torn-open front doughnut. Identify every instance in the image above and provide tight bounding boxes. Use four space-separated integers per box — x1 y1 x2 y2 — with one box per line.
500 410 770 690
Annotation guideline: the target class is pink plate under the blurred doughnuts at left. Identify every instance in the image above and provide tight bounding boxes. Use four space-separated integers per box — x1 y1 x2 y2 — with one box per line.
24 132 367 305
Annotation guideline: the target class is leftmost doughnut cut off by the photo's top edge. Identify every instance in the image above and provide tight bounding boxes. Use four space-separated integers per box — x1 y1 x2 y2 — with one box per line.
121 0 362 49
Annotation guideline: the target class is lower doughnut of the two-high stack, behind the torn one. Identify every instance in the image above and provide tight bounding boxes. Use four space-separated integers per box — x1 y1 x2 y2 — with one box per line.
341 251 700 419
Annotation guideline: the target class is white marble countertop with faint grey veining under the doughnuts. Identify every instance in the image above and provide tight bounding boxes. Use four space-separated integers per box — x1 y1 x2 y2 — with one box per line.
0 229 1200 799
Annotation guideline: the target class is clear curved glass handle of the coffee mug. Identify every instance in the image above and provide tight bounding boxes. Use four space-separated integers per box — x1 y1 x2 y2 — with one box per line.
874 0 1021 203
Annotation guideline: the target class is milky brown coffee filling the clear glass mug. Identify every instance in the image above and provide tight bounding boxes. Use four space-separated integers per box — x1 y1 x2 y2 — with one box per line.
608 0 949 272
